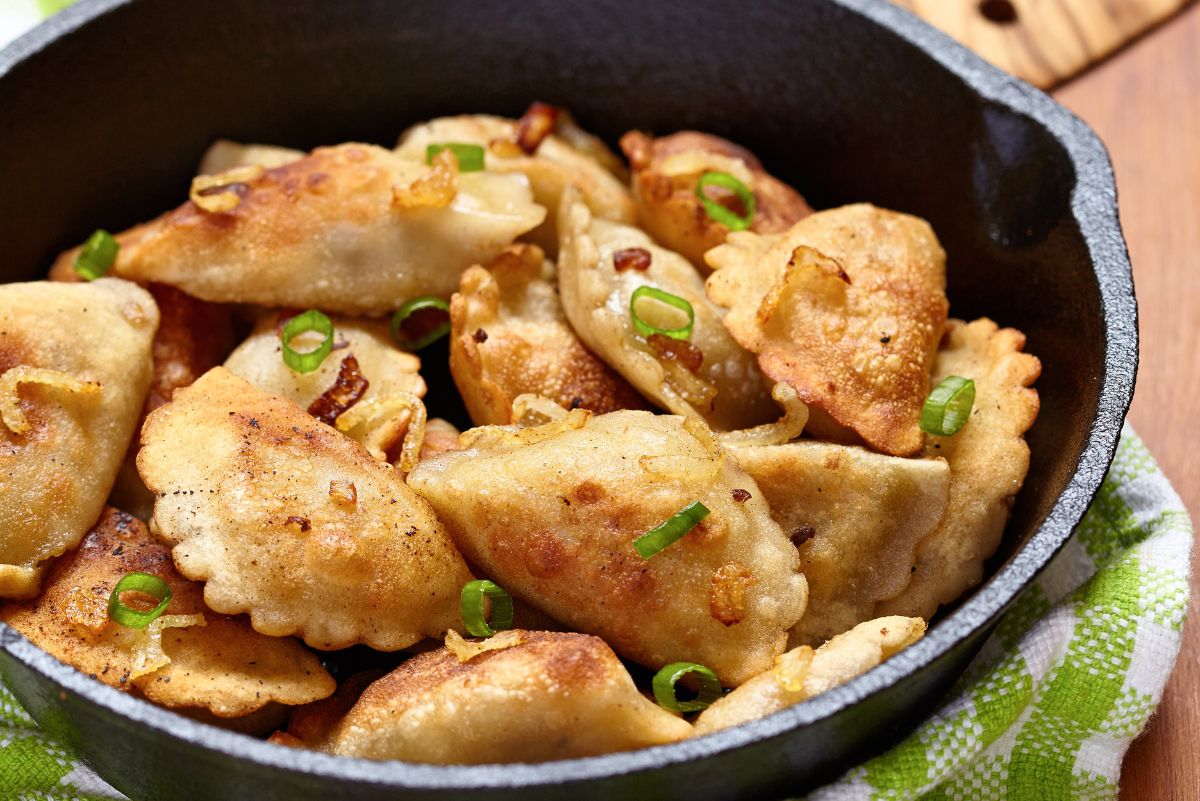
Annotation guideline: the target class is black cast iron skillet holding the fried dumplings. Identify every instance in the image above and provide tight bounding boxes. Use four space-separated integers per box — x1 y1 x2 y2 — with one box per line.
0 0 1138 801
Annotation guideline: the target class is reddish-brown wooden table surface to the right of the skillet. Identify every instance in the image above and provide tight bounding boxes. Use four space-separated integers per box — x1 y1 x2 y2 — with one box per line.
1054 5 1200 801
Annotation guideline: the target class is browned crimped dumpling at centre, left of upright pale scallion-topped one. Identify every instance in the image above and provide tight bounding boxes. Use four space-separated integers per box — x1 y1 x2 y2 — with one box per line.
450 245 648 426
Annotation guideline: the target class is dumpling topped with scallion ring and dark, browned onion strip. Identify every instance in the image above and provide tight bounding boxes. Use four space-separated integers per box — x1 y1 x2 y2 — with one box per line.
224 313 426 460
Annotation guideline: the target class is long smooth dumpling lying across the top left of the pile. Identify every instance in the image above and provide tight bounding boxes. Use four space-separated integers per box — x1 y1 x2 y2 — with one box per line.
83 144 546 315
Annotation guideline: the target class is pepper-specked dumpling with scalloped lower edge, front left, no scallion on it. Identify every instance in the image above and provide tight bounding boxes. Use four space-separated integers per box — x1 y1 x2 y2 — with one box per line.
138 367 470 651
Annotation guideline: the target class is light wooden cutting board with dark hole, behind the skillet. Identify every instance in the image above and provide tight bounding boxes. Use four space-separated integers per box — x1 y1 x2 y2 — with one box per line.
893 0 1192 89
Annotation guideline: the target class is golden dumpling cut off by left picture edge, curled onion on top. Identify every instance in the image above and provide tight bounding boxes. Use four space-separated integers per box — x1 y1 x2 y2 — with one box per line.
0 278 158 598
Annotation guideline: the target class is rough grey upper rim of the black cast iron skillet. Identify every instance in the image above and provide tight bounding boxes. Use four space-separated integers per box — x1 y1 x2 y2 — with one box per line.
0 0 1138 790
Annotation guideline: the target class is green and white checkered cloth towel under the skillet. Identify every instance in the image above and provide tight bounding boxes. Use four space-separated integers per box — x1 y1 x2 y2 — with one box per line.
0 428 1192 801
